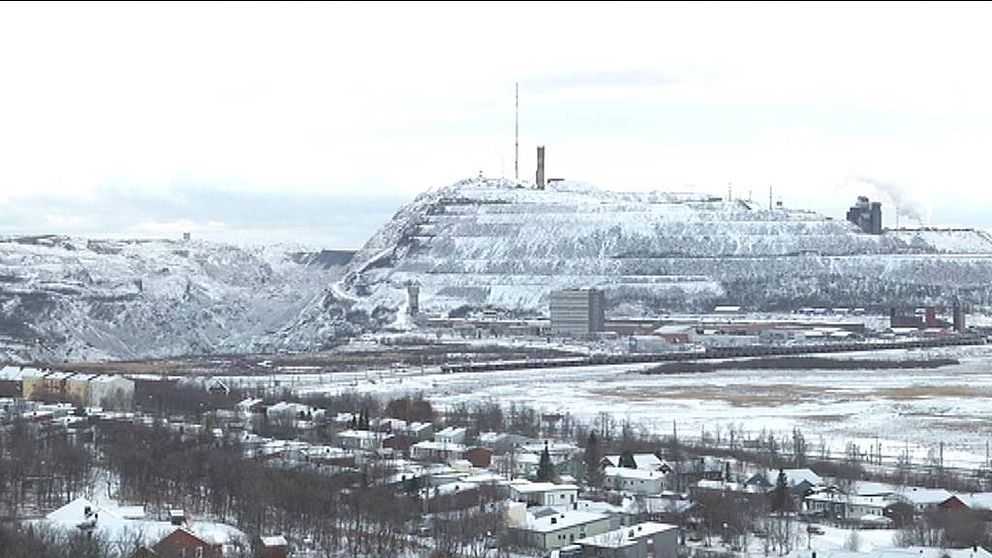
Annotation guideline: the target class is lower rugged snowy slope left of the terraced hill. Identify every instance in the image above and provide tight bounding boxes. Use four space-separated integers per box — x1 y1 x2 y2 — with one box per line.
0 236 351 361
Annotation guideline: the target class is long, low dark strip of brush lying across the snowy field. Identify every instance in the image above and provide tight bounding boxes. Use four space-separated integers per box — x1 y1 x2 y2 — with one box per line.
641 357 960 374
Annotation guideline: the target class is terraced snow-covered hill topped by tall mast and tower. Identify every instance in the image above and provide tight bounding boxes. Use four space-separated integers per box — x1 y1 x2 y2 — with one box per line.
287 179 992 337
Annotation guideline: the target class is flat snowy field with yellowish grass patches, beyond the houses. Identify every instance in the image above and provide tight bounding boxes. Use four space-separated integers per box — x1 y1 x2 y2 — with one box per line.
213 346 992 467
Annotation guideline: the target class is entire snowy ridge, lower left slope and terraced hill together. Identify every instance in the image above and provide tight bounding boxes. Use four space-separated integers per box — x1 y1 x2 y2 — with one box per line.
7 179 992 361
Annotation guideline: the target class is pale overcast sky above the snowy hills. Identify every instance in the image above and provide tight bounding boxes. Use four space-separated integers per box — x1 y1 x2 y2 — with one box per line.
0 3 992 248
